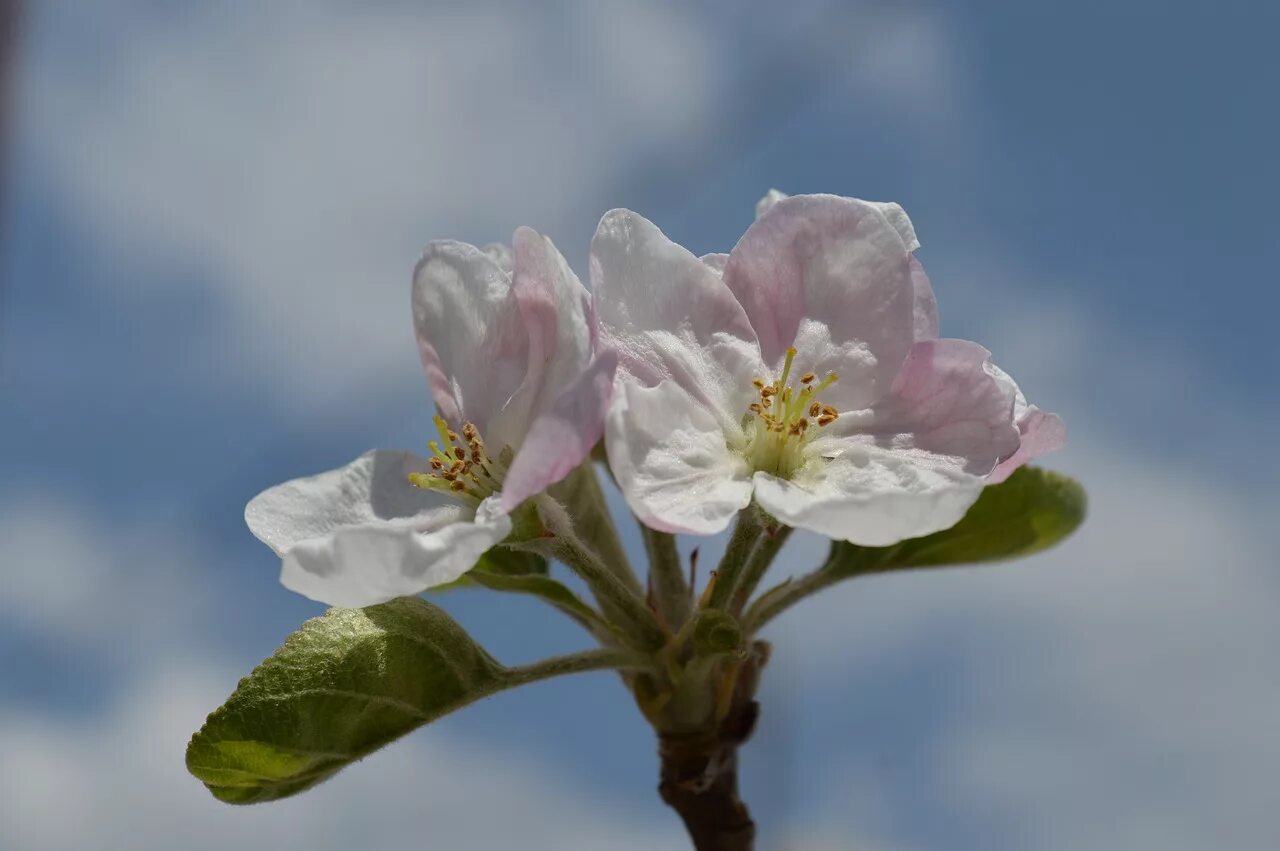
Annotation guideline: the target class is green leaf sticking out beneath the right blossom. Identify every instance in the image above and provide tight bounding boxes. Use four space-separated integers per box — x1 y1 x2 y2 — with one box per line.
824 467 1087 577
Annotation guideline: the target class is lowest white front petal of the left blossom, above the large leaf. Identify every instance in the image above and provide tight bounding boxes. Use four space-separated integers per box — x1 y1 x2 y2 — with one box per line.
280 497 511 608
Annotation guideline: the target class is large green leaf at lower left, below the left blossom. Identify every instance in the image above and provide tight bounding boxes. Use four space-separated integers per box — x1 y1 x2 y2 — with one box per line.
187 598 504 804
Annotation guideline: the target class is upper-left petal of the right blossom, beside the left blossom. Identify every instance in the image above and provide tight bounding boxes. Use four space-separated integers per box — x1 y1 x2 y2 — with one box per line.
591 210 763 427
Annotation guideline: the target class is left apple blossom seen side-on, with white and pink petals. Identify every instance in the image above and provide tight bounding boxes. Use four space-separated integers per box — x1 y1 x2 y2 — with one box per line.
244 228 617 607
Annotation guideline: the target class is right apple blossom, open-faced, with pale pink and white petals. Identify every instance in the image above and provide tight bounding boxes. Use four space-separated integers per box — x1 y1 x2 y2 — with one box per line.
591 193 1061 546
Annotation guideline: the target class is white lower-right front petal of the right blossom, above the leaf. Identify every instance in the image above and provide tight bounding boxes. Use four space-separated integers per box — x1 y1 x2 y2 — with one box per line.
755 445 983 546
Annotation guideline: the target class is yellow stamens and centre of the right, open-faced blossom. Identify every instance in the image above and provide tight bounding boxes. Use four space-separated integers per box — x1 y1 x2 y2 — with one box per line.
742 347 840 479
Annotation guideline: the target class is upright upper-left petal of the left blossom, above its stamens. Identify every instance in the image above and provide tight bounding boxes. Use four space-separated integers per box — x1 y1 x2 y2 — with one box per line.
412 241 529 447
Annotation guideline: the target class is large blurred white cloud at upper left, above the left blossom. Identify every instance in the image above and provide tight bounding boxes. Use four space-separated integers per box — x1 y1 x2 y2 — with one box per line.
18 1 713 406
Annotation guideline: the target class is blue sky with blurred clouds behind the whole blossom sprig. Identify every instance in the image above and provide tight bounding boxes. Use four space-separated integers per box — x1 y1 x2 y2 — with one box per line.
0 0 1280 851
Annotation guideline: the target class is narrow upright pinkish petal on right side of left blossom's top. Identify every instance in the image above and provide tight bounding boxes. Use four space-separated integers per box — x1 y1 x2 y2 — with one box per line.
512 228 591 420
